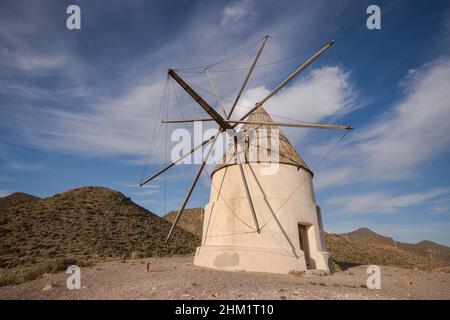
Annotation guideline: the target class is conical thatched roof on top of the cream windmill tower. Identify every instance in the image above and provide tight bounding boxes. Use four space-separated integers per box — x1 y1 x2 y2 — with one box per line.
213 108 313 175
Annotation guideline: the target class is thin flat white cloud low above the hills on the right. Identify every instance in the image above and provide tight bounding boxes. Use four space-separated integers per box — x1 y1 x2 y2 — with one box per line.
328 189 448 214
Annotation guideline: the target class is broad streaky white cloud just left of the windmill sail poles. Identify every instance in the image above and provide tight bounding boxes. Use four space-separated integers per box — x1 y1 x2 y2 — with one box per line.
12 83 168 160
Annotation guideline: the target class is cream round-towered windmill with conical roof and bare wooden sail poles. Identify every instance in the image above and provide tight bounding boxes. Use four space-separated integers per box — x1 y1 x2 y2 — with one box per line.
140 36 352 273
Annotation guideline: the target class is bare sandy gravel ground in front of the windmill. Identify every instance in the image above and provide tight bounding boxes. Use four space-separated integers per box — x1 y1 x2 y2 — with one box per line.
0 257 450 299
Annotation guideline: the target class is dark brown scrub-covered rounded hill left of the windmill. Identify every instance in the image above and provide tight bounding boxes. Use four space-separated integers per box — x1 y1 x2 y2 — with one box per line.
0 187 200 284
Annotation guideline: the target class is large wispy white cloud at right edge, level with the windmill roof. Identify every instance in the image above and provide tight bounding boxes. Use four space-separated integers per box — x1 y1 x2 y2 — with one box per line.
358 59 450 176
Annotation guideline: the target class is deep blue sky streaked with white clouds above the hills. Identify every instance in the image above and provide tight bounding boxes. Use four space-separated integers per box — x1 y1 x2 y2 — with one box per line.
0 0 450 245
